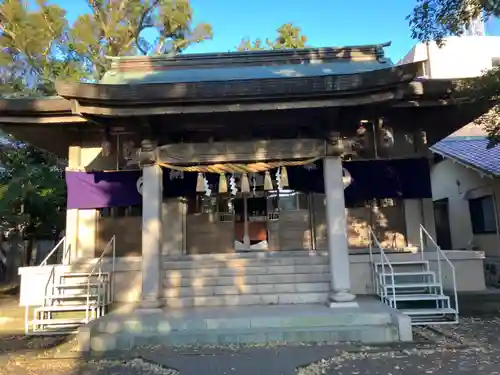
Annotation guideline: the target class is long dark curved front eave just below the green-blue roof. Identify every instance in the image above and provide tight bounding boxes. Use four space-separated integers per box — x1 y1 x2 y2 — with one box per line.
56 64 418 106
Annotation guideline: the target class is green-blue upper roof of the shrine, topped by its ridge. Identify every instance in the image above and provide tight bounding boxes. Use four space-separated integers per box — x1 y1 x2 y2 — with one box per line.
100 43 393 84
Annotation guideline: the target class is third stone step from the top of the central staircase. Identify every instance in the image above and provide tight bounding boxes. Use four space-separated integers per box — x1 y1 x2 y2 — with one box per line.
165 264 330 278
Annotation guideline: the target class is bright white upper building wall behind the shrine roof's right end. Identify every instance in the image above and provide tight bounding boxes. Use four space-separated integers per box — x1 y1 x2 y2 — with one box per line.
399 36 500 78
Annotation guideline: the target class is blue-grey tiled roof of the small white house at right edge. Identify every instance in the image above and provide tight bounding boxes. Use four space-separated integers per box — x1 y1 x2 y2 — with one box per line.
431 137 500 177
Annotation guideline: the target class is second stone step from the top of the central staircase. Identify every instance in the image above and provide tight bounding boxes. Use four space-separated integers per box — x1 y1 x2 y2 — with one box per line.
163 256 328 270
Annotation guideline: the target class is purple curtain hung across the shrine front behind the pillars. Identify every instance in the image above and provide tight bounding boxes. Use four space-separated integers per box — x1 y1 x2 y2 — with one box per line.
66 158 432 209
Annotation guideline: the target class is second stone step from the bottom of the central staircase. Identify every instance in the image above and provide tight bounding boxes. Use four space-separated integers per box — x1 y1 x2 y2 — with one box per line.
163 282 330 298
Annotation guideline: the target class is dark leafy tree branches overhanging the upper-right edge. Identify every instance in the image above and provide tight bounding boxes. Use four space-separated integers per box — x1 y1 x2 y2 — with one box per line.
408 0 500 146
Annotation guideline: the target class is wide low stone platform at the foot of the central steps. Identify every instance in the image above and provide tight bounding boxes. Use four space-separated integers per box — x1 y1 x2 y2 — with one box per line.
78 297 412 351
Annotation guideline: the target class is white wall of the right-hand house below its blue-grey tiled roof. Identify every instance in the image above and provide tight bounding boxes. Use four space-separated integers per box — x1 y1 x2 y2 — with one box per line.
431 159 500 257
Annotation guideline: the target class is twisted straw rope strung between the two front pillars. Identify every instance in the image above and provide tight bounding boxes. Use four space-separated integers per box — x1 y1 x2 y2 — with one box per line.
158 158 320 173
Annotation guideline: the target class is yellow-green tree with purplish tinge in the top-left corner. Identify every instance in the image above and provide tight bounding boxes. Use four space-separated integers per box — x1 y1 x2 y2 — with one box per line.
0 0 84 96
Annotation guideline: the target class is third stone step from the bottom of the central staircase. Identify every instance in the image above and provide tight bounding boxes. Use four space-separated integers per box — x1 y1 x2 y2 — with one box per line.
163 272 330 288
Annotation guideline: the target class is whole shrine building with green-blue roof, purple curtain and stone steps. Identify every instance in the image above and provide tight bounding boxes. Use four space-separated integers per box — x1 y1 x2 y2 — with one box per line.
0 44 489 345
